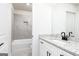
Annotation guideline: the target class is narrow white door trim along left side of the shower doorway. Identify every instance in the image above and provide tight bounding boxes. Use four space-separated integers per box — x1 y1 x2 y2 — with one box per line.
8 3 14 56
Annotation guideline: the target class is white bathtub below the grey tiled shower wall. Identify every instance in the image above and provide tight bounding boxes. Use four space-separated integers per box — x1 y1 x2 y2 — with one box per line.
12 39 32 56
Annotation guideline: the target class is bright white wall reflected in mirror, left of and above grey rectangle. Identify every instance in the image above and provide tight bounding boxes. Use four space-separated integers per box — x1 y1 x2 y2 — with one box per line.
52 3 77 34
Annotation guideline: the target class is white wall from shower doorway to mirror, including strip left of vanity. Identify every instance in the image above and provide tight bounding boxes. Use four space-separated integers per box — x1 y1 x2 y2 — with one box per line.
32 4 51 56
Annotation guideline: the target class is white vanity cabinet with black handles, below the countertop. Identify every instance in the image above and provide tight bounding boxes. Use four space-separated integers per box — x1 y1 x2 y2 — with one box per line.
40 40 72 56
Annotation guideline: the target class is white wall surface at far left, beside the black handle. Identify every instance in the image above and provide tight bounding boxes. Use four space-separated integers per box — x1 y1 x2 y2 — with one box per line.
0 3 11 53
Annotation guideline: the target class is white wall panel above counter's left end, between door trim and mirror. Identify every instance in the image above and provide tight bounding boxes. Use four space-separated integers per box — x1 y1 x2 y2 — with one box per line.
38 4 51 34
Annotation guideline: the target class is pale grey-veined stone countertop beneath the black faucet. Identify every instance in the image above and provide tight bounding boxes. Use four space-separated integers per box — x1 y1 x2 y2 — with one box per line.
39 35 79 56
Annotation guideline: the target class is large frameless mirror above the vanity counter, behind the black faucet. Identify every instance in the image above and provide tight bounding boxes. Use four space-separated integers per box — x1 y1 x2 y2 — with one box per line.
52 3 79 36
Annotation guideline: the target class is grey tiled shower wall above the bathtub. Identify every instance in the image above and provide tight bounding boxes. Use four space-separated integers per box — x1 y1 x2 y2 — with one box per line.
13 12 32 39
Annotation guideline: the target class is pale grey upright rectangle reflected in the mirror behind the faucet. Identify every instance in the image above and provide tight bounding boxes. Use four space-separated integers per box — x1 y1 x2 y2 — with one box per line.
66 11 76 34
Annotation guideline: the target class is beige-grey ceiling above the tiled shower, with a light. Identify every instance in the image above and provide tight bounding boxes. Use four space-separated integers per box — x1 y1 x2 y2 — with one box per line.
13 3 32 11
